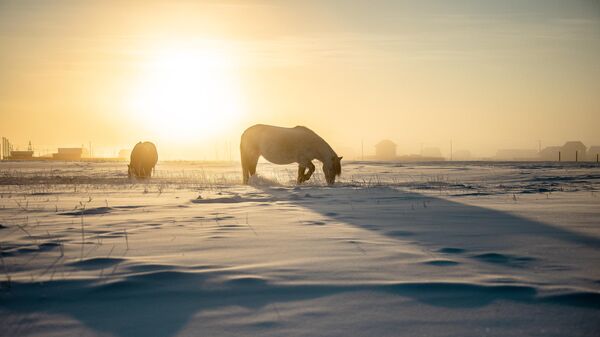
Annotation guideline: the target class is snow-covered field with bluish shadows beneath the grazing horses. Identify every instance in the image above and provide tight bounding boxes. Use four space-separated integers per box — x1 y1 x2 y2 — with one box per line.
0 162 600 337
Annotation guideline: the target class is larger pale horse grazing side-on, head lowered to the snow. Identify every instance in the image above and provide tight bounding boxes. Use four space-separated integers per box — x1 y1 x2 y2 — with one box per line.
240 124 342 185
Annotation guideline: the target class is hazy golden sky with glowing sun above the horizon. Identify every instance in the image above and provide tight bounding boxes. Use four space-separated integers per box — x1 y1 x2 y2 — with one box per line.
0 0 600 159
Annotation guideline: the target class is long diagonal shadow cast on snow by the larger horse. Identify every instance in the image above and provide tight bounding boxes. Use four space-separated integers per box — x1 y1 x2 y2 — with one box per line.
258 185 600 253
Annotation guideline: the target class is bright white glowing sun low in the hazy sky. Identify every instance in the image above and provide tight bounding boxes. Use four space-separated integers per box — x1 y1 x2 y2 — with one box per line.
131 48 242 140
